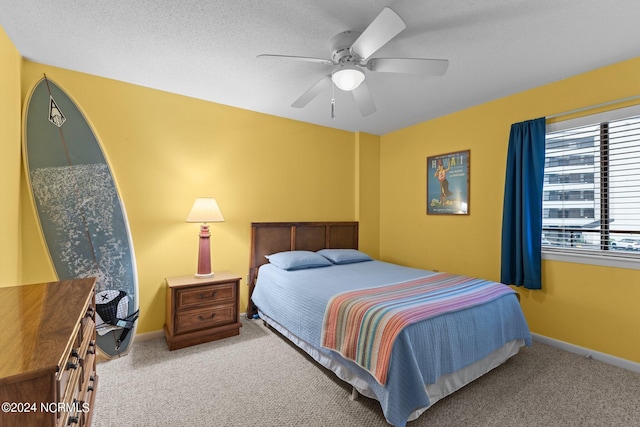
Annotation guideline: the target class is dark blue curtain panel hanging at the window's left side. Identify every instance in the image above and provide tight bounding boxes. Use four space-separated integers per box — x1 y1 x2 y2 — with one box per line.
500 117 545 289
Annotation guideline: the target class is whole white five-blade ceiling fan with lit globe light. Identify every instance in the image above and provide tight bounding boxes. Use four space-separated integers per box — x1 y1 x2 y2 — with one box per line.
258 7 449 117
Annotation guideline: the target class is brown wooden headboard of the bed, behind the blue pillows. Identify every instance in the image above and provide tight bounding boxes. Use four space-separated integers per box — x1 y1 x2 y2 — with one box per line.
247 221 358 318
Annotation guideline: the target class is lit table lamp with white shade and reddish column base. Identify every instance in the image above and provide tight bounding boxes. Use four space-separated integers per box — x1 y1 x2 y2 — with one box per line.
187 197 224 279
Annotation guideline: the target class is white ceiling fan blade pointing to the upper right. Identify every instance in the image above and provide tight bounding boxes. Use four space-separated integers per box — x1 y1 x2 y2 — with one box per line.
351 7 407 59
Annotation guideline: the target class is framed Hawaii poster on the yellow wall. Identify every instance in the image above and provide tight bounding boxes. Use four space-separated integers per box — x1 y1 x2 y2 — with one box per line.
427 150 469 215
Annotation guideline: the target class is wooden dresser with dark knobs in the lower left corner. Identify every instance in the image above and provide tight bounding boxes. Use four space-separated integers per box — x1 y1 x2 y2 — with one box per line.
0 278 98 427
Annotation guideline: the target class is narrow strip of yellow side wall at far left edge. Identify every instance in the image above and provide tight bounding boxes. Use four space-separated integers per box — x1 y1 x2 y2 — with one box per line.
0 27 22 286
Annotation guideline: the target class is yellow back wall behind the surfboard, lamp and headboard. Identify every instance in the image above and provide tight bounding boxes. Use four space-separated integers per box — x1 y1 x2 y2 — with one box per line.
22 61 364 333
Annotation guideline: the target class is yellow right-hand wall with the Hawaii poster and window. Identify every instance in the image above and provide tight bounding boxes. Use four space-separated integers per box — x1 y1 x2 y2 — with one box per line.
380 58 640 362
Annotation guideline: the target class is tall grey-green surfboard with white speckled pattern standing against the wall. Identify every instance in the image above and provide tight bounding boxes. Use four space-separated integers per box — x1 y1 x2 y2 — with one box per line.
23 76 139 358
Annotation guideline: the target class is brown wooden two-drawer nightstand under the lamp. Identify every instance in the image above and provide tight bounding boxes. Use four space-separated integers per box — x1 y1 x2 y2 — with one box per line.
164 271 242 350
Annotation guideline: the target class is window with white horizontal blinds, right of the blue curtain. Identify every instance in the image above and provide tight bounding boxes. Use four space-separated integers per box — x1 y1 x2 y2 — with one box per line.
542 106 640 268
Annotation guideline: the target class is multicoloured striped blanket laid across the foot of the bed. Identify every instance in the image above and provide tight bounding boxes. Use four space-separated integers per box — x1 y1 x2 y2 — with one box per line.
321 273 515 385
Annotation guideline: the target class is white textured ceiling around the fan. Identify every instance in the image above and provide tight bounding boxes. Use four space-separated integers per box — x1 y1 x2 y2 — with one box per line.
0 0 640 135
